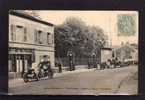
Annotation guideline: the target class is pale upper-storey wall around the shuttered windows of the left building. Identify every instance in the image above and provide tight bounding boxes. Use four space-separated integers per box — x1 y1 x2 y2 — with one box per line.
9 15 54 46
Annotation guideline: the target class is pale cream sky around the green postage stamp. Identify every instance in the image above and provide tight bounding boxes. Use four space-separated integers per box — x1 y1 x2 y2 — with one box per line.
29 10 138 45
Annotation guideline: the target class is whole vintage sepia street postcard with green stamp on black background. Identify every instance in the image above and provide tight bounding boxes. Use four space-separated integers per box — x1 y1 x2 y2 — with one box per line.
8 10 138 96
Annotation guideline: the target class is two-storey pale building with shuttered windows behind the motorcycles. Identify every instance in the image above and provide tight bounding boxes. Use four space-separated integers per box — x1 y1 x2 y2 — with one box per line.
8 11 55 78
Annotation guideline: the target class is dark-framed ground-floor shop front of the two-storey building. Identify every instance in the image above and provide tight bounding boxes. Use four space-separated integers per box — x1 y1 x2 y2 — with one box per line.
8 48 34 78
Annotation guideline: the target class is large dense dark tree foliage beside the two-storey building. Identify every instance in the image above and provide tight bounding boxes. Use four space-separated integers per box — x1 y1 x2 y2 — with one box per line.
54 17 107 57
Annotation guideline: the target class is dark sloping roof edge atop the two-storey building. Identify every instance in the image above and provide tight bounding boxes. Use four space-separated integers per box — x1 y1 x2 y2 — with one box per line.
9 10 54 26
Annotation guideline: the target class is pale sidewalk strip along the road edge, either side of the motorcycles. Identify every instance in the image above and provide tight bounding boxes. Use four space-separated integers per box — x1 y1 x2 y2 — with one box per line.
9 66 96 87
